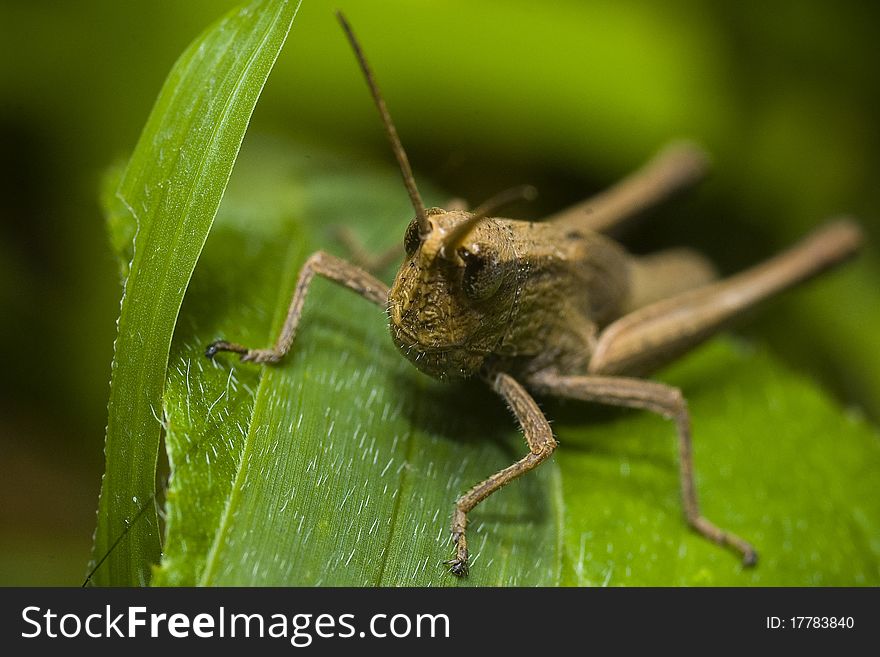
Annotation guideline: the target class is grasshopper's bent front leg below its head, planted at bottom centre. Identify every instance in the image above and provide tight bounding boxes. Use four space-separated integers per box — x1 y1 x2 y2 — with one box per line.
446 372 557 577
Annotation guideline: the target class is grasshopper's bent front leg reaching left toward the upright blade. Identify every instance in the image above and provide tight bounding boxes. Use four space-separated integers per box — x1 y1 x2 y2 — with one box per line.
205 251 388 363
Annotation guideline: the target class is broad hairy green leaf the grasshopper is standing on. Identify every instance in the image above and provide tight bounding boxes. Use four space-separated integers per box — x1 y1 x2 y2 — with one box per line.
154 137 880 586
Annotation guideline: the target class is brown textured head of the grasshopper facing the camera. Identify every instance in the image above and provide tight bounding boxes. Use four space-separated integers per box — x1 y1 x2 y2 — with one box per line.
388 208 517 379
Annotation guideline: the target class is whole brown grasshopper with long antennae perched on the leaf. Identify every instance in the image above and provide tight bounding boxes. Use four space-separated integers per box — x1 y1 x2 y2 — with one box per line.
206 14 862 576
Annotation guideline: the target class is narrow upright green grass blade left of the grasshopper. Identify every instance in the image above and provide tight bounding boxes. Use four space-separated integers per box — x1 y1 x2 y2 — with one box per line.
91 0 298 585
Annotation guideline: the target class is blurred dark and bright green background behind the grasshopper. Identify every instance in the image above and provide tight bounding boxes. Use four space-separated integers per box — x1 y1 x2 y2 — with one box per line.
0 0 880 585
